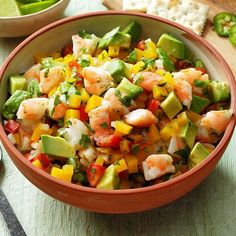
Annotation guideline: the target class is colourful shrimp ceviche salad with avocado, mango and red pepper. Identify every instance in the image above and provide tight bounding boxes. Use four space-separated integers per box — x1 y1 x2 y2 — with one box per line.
2 21 232 189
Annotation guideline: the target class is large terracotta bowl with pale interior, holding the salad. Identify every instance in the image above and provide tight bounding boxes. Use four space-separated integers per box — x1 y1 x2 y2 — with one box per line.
0 11 236 214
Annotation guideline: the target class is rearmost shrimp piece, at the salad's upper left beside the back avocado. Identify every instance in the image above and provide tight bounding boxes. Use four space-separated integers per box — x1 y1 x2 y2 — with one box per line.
72 34 99 58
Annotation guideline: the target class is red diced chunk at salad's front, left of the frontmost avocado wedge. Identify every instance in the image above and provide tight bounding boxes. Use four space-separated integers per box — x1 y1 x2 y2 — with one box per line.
86 164 106 187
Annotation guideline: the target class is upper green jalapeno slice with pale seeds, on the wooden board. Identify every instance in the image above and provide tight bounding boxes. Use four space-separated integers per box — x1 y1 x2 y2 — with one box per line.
213 12 236 37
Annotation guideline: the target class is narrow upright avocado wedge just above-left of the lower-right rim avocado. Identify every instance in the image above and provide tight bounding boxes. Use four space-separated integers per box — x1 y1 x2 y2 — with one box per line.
179 121 198 149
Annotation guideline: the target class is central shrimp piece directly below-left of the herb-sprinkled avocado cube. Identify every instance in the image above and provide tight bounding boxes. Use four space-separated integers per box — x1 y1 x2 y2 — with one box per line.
103 88 129 116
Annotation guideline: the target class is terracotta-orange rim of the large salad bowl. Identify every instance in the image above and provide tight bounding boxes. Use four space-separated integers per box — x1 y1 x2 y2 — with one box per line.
0 11 236 195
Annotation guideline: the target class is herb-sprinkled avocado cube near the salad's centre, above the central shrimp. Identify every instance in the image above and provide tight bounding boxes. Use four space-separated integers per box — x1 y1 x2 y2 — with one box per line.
116 77 143 99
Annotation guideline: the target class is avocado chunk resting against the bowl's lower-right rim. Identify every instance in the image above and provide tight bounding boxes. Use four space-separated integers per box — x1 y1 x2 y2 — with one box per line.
188 142 210 168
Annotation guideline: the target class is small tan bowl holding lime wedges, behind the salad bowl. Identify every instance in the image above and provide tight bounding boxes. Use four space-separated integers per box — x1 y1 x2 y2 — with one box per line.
0 0 70 38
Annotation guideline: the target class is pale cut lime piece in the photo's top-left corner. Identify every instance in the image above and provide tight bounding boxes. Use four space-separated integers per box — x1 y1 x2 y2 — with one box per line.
0 0 21 17
